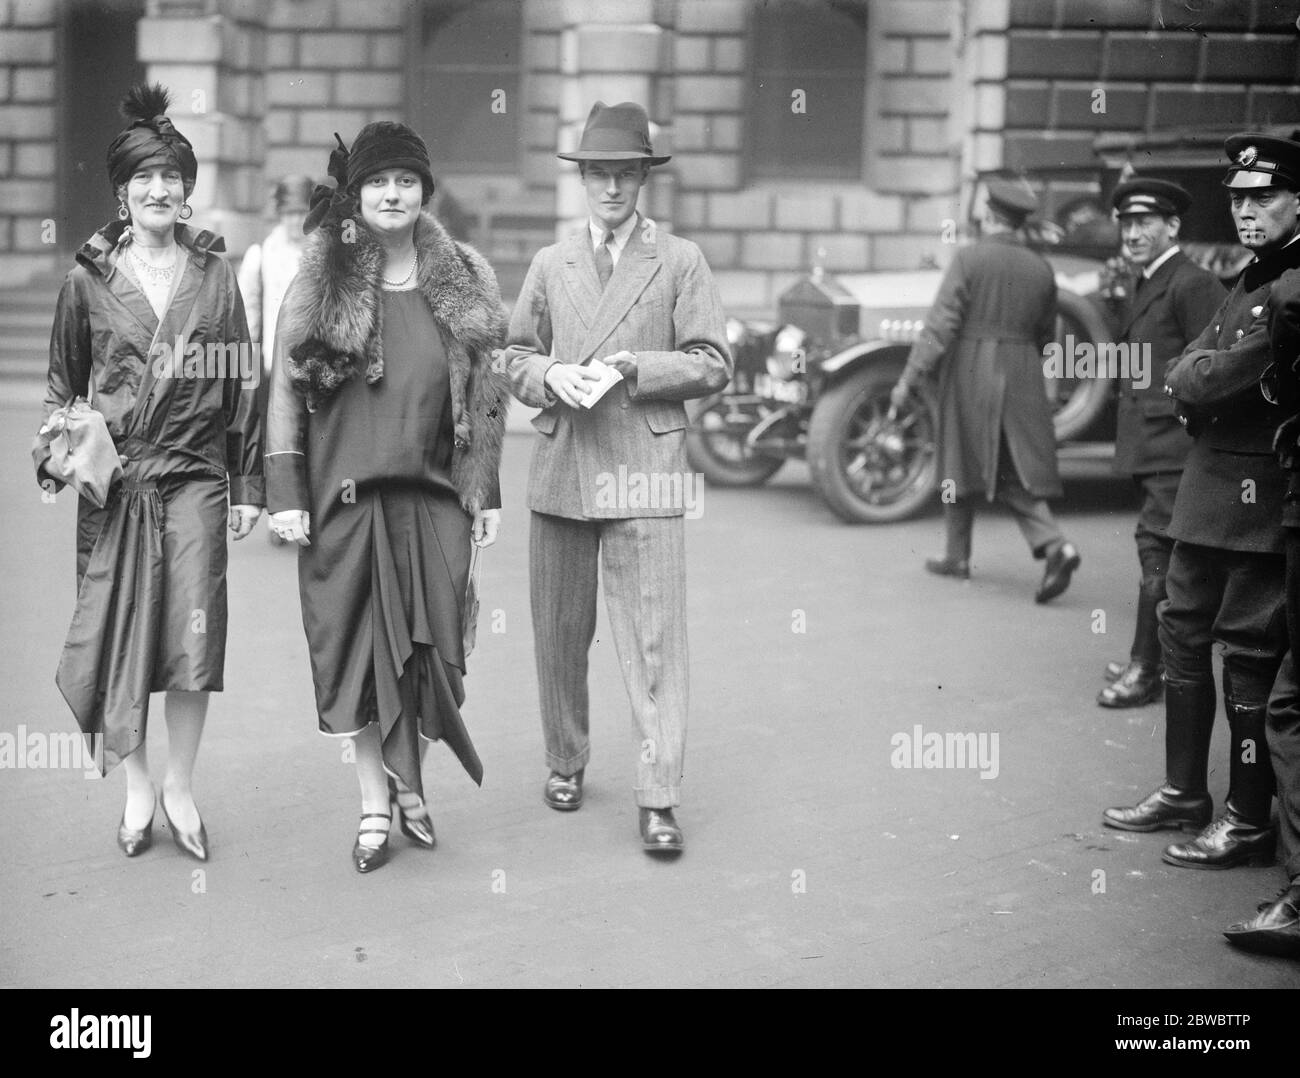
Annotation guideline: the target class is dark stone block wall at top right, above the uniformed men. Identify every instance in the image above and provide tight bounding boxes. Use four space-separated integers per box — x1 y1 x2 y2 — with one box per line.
976 0 1300 169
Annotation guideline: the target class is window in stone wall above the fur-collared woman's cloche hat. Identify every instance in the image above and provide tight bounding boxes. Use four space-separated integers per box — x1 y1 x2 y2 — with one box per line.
408 0 523 173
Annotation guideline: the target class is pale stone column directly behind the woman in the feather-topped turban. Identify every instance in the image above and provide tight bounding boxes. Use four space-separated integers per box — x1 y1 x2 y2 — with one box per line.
139 0 267 255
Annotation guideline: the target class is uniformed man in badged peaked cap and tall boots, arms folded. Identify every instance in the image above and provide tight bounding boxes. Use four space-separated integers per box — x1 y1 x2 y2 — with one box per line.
1104 134 1300 869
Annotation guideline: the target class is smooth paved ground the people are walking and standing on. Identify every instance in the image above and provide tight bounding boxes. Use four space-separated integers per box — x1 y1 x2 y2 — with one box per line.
0 402 1300 987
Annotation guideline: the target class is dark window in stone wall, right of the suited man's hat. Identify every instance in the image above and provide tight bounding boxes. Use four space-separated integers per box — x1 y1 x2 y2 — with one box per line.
745 0 867 179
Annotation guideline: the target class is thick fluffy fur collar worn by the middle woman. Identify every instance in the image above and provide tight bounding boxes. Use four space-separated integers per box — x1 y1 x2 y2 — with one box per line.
280 212 510 512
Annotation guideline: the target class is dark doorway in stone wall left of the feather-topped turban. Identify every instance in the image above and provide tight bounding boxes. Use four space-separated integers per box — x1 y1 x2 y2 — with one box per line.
57 0 144 254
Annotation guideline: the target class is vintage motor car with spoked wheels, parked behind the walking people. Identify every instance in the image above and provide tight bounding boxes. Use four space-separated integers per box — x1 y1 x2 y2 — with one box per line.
686 131 1249 523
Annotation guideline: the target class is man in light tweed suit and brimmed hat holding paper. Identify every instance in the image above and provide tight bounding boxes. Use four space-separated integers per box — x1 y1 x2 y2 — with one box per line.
504 101 732 853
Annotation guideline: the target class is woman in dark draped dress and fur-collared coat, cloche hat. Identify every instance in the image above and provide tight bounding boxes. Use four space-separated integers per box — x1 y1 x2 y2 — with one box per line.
267 122 508 873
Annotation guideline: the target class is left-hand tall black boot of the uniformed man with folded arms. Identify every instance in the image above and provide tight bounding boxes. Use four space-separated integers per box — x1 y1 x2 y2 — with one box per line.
1101 680 1216 831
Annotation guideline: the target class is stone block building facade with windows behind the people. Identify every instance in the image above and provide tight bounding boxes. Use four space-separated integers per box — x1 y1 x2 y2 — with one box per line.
0 0 1300 312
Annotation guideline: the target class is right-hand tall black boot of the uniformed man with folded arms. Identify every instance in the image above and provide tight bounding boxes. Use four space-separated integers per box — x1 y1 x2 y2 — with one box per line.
1164 697 1277 869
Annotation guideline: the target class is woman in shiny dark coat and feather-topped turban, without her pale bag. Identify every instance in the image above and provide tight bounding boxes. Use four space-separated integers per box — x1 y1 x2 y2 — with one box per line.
34 86 264 861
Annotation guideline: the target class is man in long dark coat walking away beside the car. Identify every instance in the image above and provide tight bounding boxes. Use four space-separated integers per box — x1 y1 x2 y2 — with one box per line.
891 172 1079 602
